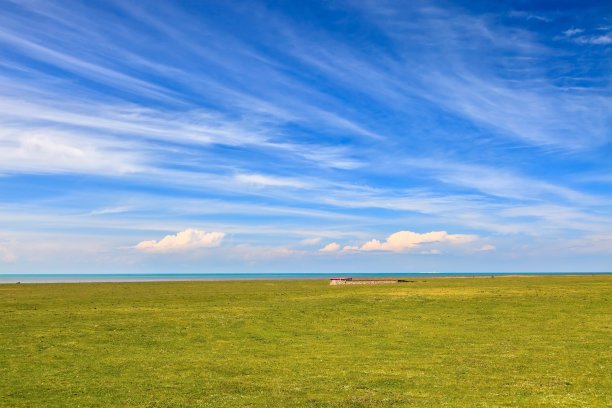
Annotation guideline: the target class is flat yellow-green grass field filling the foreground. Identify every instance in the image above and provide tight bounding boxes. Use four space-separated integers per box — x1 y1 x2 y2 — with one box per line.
0 276 612 407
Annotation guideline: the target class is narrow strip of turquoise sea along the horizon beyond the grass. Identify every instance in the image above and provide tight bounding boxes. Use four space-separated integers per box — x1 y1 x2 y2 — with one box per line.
0 272 612 284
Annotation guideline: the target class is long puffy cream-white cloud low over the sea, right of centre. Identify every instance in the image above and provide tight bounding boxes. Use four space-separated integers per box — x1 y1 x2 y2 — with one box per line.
359 231 477 252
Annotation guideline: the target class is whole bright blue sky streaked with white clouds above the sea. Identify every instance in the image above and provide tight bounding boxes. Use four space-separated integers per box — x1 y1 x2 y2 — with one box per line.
0 0 612 274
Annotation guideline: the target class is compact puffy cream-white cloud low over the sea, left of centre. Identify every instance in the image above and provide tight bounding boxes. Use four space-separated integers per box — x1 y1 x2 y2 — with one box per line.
134 228 225 253
